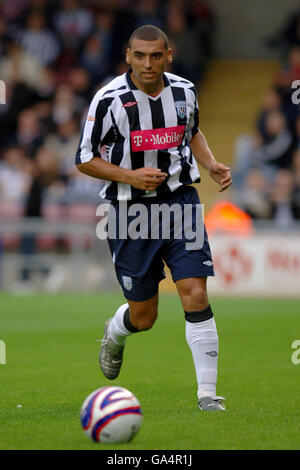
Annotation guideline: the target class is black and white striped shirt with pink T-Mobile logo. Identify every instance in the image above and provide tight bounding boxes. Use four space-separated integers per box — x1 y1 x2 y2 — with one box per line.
76 70 200 200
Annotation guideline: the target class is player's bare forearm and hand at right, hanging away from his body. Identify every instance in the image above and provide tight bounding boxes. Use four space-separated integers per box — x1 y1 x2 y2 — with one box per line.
190 129 232 192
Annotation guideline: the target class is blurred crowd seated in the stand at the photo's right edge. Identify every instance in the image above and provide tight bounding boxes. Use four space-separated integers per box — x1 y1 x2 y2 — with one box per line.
233 10 300 228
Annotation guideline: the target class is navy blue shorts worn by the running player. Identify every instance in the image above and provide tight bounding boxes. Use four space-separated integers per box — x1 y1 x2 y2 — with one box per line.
108 186 214 302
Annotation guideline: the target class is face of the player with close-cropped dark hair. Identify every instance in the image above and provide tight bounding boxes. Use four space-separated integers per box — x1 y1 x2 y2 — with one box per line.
126 38 172 91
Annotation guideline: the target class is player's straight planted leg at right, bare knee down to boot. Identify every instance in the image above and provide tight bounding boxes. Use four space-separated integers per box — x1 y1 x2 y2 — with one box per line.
175 277 225 411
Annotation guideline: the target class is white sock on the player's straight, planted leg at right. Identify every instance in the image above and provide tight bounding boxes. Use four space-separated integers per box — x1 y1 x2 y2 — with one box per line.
185 318 219 398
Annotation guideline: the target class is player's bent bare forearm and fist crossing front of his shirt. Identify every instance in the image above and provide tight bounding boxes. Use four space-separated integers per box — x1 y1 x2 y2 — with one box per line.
76 156 168 191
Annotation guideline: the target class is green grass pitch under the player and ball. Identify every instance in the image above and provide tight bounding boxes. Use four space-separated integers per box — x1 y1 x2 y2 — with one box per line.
0 293 300 450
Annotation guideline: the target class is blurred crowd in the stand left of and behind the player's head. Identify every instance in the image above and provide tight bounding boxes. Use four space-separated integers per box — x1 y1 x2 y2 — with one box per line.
0 0 214 220
